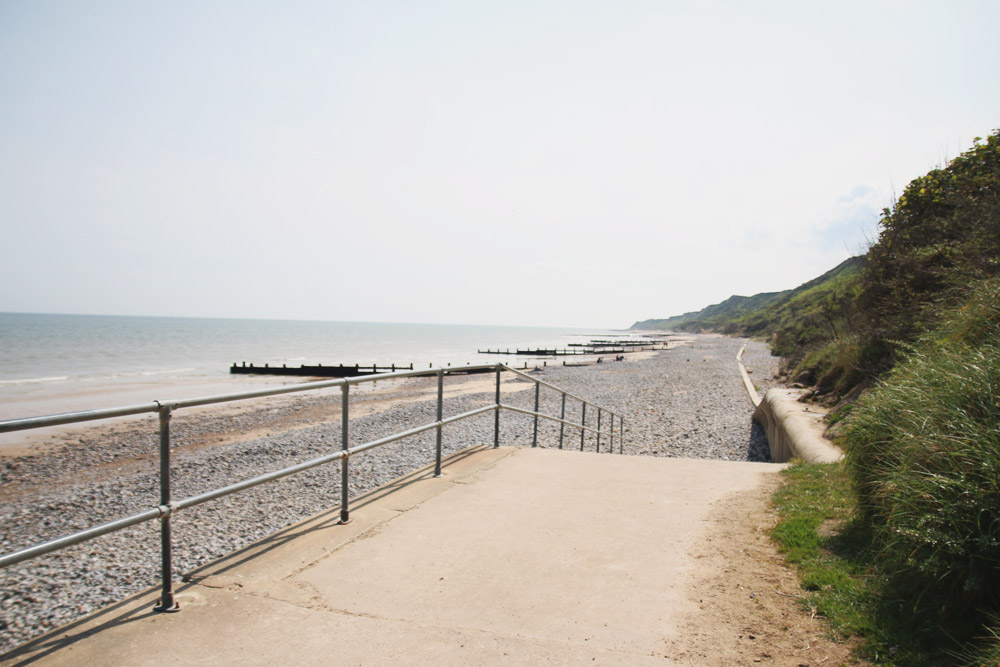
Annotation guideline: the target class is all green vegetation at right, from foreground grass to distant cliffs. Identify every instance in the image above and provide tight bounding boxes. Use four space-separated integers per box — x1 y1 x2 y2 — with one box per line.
636 131 1000 666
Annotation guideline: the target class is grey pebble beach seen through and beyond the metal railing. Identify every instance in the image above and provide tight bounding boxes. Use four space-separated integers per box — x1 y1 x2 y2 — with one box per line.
0 335 778 653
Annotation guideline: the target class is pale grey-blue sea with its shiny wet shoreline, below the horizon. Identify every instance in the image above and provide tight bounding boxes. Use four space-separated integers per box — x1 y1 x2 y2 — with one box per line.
0 313 627 419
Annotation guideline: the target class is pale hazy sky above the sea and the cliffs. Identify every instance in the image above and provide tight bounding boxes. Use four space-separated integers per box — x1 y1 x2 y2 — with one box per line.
0 0 1000 328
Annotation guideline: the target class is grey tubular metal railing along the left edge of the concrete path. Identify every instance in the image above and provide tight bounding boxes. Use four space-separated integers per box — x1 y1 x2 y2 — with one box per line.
0 364 625 611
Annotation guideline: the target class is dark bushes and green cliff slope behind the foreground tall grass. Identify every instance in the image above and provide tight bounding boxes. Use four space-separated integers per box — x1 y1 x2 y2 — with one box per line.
633 131 1000 405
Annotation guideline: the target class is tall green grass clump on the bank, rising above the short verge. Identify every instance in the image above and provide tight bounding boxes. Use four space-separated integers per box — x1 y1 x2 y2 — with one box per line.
842 279 1000 652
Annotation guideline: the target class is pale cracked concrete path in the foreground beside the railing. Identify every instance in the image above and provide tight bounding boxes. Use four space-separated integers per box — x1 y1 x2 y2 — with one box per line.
2 448 783 665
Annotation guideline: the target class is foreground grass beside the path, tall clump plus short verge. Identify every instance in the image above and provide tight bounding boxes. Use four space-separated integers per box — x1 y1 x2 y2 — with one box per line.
774 279 1000 666
